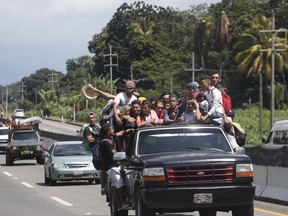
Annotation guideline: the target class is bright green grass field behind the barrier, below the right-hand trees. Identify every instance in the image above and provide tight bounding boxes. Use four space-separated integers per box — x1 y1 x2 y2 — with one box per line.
234 105 288 144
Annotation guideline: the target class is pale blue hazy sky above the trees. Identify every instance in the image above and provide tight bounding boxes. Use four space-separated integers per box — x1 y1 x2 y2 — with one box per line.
0 0 221 86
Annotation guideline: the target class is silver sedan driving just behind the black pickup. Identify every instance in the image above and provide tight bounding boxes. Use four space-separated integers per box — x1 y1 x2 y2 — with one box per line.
44 141 100 186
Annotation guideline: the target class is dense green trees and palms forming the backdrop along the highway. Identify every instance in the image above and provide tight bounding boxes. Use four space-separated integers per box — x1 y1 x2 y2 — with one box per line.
0 0 288 145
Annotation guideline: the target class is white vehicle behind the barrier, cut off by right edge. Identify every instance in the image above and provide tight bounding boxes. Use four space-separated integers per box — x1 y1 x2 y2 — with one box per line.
262 120 288 146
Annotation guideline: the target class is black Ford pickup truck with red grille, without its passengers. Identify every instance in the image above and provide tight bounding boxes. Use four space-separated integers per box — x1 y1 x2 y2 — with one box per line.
109 124 255 216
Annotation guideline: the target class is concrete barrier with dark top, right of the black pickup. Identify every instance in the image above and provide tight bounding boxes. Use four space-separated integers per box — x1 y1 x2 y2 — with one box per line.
245 145 288 205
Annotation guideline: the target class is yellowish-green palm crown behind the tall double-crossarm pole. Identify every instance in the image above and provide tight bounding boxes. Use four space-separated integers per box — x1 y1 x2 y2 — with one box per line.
233 15 288 80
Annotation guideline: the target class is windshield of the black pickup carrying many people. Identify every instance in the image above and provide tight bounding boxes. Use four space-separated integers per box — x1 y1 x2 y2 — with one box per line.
137 128 231 154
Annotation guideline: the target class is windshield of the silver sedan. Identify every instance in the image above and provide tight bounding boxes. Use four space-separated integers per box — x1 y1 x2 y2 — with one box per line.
53 143 91 156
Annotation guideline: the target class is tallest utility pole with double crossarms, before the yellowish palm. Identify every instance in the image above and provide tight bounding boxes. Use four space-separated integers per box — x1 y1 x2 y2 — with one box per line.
260 10 287 128
